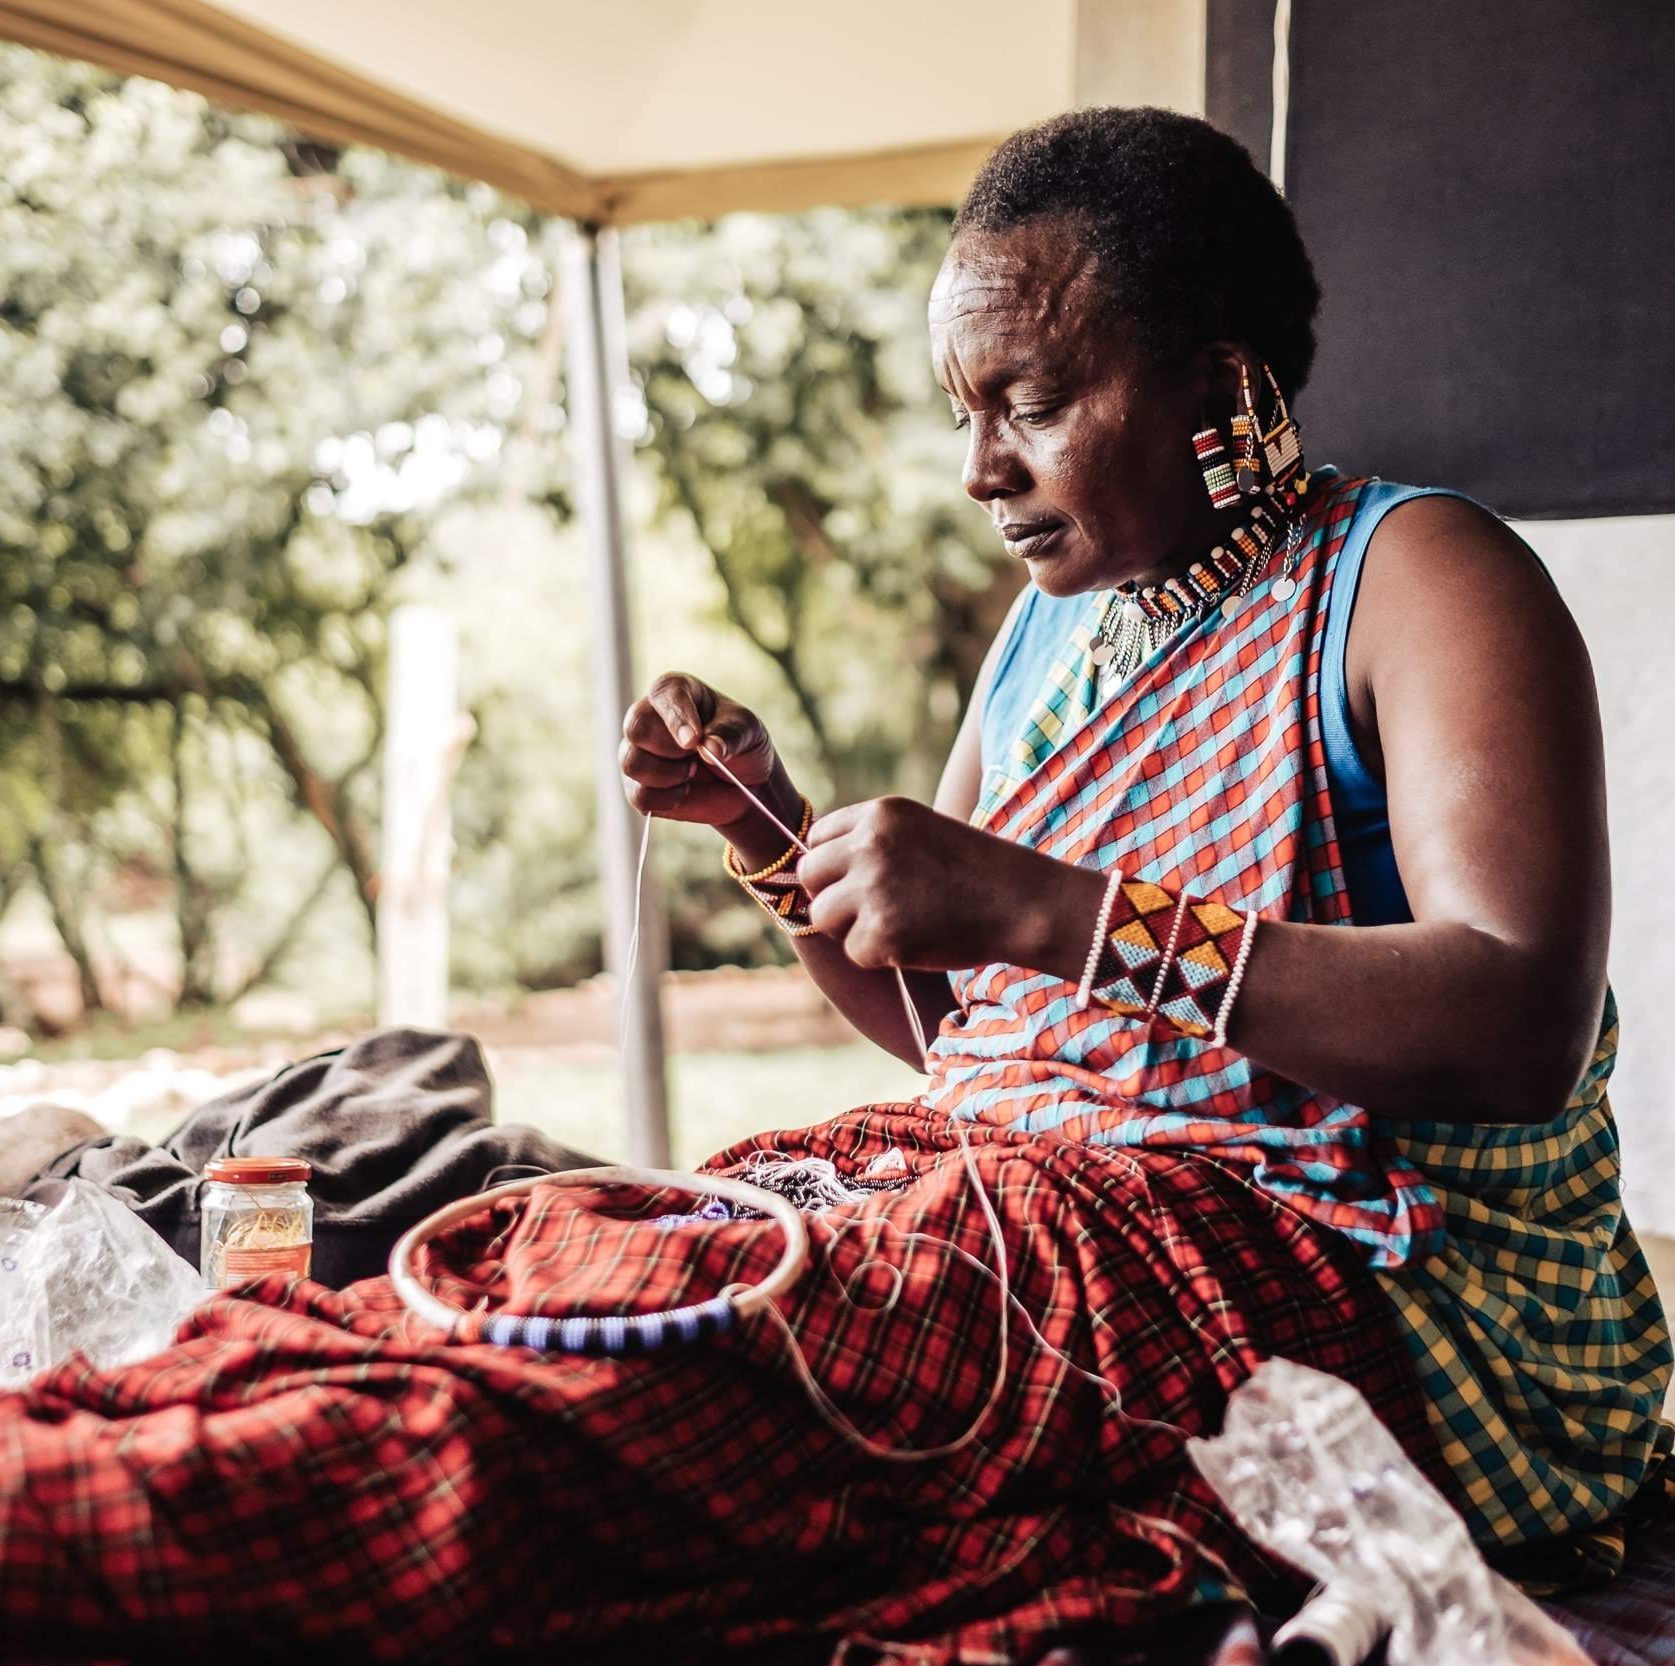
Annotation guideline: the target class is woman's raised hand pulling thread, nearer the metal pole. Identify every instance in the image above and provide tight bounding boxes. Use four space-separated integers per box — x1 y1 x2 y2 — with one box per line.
618 671 797 849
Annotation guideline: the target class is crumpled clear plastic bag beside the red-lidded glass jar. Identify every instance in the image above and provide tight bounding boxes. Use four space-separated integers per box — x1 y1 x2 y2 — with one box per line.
0 1180 208 1388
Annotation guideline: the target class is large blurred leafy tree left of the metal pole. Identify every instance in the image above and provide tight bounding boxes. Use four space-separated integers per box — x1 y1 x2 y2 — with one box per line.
0 49 556 1005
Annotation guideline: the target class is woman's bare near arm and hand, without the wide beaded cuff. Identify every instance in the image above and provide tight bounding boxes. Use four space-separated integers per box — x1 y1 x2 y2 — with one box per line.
802 499 1610 1122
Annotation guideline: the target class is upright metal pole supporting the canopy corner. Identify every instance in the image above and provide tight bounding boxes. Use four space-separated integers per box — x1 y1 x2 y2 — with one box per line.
563 226 670 1169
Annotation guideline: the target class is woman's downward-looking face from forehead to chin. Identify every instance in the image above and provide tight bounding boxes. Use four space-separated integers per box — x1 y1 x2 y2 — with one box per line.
930 219 1229 596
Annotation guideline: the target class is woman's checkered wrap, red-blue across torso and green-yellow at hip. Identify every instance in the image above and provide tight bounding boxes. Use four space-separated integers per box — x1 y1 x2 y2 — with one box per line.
926 476 1670 1561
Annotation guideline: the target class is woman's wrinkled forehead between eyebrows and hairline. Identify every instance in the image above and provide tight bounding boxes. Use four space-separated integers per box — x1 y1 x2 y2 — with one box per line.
930 223 1119 380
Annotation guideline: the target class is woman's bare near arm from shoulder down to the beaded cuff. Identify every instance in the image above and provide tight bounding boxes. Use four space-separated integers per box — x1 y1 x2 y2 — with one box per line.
1231 497 1611 1122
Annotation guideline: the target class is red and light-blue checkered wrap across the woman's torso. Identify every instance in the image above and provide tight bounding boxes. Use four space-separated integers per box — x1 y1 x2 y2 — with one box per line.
926 476 1442 1266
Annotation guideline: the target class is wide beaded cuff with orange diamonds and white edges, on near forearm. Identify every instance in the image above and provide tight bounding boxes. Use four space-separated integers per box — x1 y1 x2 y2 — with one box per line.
1092 879 1256 1043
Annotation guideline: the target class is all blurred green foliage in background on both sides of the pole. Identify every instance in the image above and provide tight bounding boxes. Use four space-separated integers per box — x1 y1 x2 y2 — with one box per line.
0 49 1010 1031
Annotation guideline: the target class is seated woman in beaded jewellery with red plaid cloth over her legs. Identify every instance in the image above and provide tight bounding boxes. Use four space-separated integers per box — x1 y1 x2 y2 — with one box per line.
0 111 1670 1666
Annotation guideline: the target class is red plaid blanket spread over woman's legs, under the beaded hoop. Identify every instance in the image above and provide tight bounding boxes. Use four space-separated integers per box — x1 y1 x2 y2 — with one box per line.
0 1107 1435 1666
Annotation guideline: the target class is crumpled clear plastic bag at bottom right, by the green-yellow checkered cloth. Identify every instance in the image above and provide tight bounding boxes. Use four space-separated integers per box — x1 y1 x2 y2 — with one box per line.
1188 1360 1590 1666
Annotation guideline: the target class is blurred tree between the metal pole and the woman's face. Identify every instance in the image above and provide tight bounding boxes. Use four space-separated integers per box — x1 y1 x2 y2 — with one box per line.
626 209 1017 799
